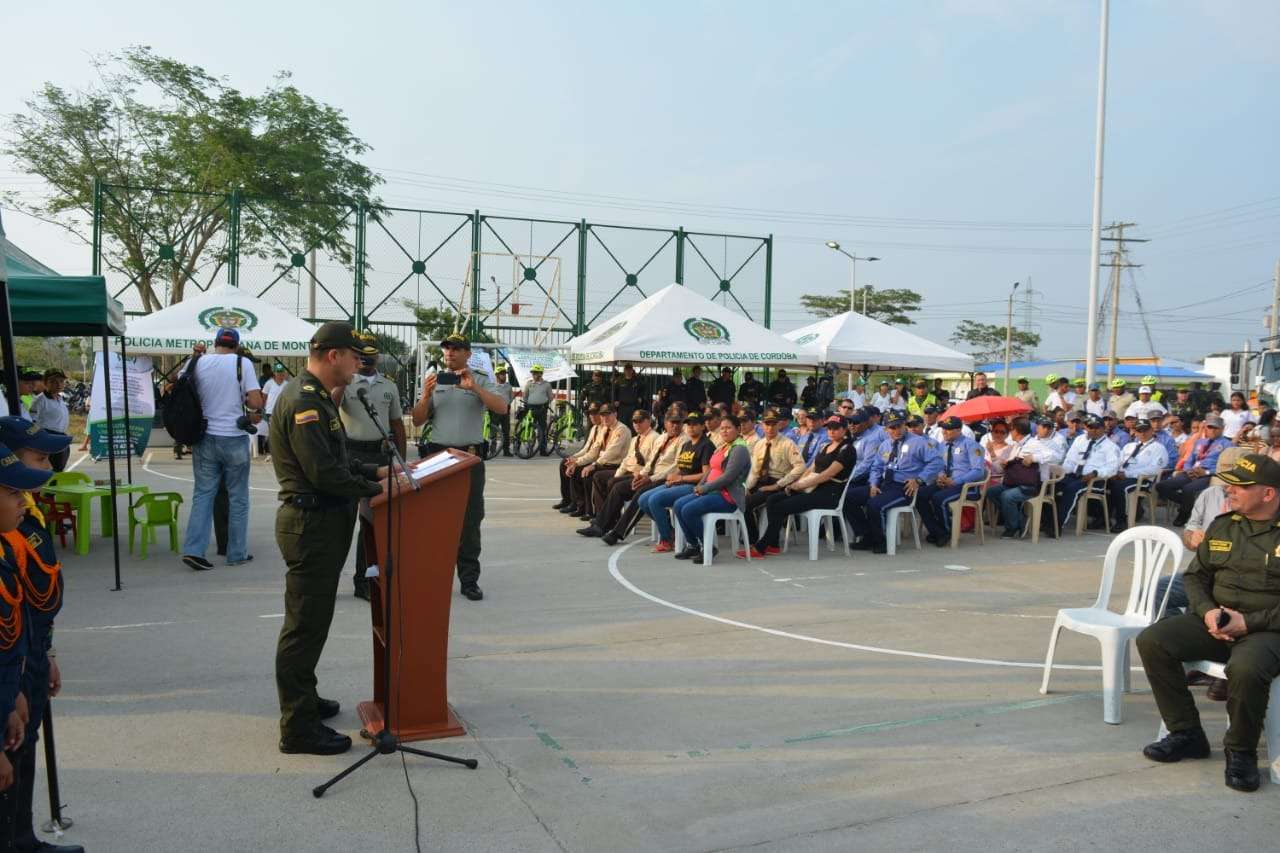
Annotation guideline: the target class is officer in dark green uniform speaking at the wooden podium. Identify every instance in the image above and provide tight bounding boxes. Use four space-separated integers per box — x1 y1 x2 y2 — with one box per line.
271 323 385 756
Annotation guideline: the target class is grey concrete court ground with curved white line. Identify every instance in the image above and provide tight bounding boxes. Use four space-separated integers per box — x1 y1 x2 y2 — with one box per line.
37 451 1280 853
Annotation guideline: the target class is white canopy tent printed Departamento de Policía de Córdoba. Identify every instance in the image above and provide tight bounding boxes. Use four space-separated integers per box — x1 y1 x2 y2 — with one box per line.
564 284 818 366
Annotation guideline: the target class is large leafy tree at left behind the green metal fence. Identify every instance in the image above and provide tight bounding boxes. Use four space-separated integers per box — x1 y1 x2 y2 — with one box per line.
3 47 381 311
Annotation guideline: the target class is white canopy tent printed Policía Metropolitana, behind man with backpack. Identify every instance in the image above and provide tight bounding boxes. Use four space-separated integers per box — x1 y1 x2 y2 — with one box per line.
111 284 316 356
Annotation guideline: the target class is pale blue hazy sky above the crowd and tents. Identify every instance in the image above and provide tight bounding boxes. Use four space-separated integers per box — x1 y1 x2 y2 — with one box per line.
0 0 1280 360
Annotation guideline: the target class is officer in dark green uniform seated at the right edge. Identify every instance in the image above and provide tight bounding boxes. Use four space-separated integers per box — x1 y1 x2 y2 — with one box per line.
1138 453 1280 792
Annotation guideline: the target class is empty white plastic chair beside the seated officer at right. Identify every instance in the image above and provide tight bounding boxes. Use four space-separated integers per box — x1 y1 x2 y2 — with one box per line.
1041 525 1183 725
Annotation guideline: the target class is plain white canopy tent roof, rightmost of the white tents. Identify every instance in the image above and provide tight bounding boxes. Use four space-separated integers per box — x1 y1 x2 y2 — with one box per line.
786 311 973 373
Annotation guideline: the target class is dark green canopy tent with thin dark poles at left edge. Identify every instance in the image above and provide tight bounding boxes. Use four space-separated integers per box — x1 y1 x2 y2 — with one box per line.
0 211 133 589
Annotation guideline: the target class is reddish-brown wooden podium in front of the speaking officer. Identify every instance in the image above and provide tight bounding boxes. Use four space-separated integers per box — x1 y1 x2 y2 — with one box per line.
356 450 480 742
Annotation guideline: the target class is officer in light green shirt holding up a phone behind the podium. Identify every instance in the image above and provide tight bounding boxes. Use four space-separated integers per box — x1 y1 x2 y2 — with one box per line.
413 334 507 601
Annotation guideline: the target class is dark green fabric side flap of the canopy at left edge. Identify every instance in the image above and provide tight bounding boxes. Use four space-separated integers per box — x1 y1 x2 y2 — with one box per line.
9 275 124 337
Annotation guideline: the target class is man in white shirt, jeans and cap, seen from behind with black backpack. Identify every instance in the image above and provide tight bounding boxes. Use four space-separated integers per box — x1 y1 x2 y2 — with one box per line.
182 328 265 571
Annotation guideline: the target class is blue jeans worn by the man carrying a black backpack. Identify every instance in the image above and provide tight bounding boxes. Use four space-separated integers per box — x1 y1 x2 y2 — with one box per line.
182 435 250 564
